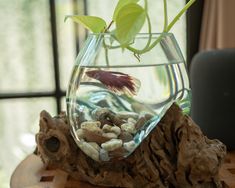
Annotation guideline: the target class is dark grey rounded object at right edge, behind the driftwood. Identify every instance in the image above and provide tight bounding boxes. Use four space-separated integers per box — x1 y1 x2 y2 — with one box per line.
189 49 235 150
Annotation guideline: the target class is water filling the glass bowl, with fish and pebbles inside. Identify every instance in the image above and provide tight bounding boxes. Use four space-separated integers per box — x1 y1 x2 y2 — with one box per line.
67 62 190 161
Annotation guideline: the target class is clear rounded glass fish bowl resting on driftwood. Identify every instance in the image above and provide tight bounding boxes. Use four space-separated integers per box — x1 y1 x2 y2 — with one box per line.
66 33 190 162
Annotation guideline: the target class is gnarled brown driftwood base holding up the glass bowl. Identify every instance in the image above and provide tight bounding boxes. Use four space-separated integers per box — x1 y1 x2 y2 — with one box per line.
12 104 226 188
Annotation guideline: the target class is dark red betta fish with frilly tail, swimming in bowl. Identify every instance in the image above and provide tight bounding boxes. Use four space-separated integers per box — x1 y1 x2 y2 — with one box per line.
86 70 140 96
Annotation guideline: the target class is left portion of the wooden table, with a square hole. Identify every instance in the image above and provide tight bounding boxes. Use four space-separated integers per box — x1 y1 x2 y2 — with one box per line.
10 154 101 188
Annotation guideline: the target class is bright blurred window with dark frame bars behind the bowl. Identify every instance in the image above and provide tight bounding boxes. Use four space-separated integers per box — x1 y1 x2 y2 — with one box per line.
0 0 186 188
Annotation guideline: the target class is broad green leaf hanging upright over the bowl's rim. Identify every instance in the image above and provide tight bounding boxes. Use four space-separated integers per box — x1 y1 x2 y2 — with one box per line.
116 3 146 47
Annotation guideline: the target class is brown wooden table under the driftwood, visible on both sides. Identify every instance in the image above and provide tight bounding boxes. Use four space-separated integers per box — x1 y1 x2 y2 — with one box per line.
10 152 235 188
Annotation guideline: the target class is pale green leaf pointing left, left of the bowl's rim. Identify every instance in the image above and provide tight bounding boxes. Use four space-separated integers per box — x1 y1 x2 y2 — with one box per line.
64 15 107 33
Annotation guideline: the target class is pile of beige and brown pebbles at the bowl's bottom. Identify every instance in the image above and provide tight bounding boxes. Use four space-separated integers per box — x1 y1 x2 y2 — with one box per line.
76 108 153 161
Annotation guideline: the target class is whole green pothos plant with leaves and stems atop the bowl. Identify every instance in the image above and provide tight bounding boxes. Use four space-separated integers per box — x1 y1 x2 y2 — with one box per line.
65 0 196 59
